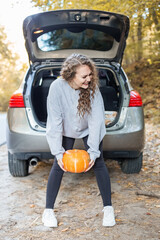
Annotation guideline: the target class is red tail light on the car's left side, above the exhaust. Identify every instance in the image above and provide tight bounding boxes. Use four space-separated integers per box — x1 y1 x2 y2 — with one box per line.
9 93 25 108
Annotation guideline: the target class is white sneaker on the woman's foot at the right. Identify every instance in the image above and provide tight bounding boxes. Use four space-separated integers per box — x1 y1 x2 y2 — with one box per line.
102 206 116 227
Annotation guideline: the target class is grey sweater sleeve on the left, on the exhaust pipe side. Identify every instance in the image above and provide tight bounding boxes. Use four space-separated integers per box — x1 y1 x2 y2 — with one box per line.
46 84 65 159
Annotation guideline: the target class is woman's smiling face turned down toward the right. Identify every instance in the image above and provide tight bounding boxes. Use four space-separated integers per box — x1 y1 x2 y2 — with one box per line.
70 65 93 89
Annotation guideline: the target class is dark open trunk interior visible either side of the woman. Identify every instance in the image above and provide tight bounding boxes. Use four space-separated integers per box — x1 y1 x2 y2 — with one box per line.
31 68 121 127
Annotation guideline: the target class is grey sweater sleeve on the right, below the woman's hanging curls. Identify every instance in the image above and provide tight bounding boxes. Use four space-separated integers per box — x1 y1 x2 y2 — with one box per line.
87 89 106 161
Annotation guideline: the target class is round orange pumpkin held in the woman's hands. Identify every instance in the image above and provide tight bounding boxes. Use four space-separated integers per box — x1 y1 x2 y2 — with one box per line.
62 149 90 173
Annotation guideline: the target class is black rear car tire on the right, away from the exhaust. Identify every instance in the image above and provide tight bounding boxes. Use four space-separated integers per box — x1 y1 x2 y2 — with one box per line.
120 153 143 174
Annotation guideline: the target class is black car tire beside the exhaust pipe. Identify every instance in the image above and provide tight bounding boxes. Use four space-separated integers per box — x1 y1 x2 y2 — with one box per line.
8 152 29 177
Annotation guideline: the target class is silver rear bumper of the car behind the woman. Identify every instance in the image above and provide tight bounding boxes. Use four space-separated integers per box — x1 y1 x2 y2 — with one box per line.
6 108 144 159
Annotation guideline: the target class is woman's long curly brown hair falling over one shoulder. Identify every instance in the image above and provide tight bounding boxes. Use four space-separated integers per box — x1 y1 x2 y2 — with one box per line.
60 53 99 117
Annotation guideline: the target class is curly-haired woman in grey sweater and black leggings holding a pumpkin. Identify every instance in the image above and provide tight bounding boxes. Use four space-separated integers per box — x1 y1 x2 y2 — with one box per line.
42 54 115 227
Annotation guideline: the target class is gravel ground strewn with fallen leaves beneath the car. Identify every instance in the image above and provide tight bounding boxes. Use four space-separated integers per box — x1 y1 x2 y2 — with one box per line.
0 123 160 240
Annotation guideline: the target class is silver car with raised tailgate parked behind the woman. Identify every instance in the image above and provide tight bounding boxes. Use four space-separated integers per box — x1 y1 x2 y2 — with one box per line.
7 10 144 177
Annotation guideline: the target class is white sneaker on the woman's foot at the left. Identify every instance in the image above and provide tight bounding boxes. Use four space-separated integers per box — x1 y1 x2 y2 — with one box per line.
42 208 57 227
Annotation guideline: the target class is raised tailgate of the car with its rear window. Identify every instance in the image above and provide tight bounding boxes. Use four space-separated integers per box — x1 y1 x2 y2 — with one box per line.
23 9 129 63
